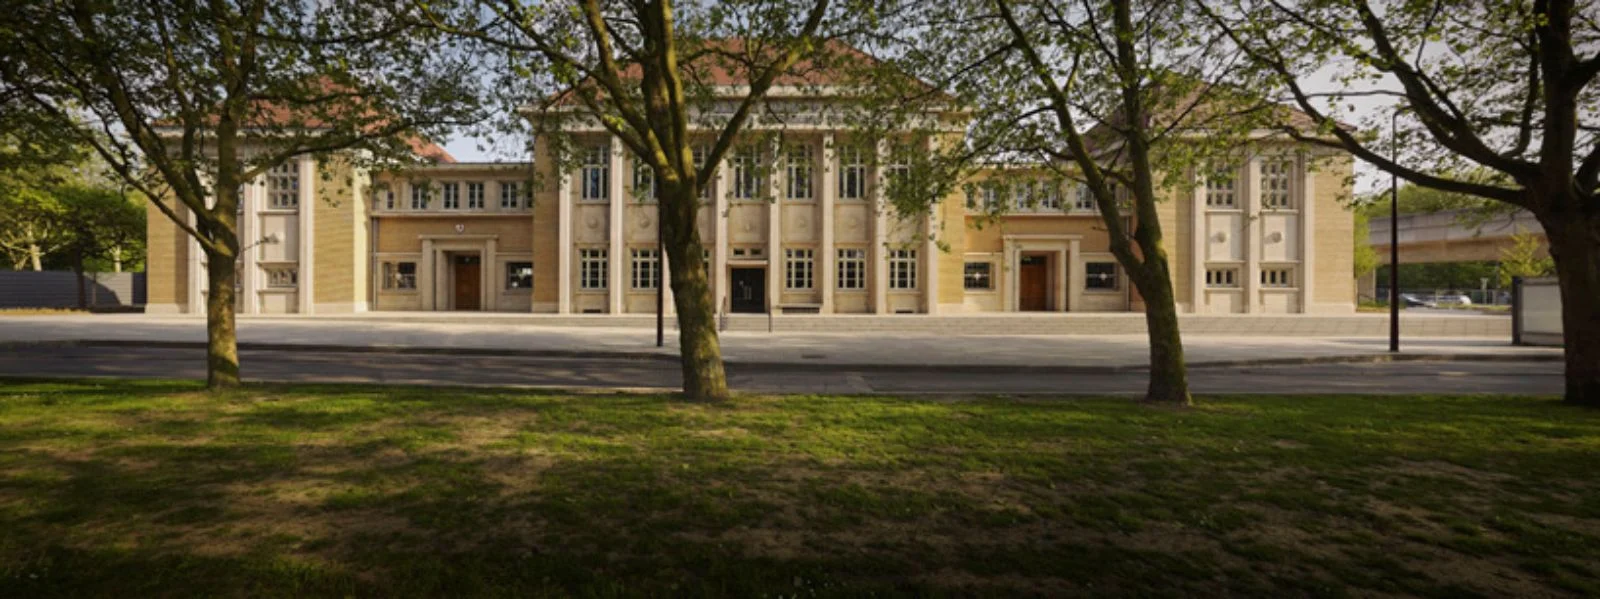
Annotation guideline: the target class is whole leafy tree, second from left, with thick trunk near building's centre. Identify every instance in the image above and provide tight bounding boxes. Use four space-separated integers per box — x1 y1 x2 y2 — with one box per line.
411 0 869 400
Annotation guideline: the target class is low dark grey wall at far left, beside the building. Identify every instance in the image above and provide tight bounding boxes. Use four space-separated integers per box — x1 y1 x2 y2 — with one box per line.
0 271 144 309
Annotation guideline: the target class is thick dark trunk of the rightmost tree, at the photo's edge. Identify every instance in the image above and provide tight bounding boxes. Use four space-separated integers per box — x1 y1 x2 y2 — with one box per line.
1541 215 1600 408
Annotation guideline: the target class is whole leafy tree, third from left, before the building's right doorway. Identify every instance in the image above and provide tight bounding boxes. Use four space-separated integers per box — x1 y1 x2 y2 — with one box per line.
885 0 1283 405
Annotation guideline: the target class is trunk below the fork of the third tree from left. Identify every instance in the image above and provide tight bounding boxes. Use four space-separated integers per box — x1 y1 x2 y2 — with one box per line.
1134 261 1194 405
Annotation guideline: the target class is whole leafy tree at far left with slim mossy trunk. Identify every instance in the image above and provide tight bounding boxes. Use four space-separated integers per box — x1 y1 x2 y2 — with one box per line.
0 0 472 389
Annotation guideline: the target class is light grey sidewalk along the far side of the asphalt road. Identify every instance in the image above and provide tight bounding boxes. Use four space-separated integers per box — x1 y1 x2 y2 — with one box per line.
0 314 1562 368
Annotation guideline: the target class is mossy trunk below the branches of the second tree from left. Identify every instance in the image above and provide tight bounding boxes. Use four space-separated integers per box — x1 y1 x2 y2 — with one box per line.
661 189 728 402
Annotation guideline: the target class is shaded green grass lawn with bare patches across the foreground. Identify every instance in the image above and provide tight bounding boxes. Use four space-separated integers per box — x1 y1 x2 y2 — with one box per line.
0 381 1600 597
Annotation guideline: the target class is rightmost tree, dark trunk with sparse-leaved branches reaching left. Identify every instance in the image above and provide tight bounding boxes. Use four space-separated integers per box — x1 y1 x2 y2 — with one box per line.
1197 0 1600 407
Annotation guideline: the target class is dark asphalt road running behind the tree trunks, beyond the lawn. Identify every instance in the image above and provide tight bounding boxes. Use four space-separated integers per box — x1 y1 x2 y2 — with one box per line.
0 346 1562 394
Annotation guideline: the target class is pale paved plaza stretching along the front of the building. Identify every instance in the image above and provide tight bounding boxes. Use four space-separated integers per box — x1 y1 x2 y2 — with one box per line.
0 314 1560 368
